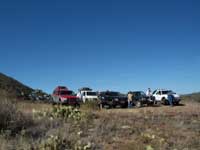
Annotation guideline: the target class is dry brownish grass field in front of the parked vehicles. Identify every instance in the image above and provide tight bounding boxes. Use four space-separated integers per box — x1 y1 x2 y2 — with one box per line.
0 98 200 150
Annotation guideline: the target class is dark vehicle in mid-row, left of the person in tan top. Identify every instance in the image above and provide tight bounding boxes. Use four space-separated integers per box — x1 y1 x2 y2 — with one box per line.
99 91 128 108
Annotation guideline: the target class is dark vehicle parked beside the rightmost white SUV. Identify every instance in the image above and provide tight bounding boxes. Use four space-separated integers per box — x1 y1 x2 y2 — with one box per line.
131 91 154 107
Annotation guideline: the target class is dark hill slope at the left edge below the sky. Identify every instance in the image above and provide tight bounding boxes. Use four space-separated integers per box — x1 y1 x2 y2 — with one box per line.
0 73 33 97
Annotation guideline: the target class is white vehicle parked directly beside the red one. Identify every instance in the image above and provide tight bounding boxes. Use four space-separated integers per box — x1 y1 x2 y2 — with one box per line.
77 87 98 103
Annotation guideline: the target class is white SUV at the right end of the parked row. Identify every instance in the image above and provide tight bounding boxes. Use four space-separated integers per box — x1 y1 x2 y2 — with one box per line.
152 89 181 105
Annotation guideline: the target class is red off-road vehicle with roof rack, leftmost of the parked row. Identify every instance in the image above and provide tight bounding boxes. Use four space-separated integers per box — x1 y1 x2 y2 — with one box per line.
52 86 79 106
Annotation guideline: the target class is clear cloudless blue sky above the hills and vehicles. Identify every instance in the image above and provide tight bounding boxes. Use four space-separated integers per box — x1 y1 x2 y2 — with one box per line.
0 0 200 93
